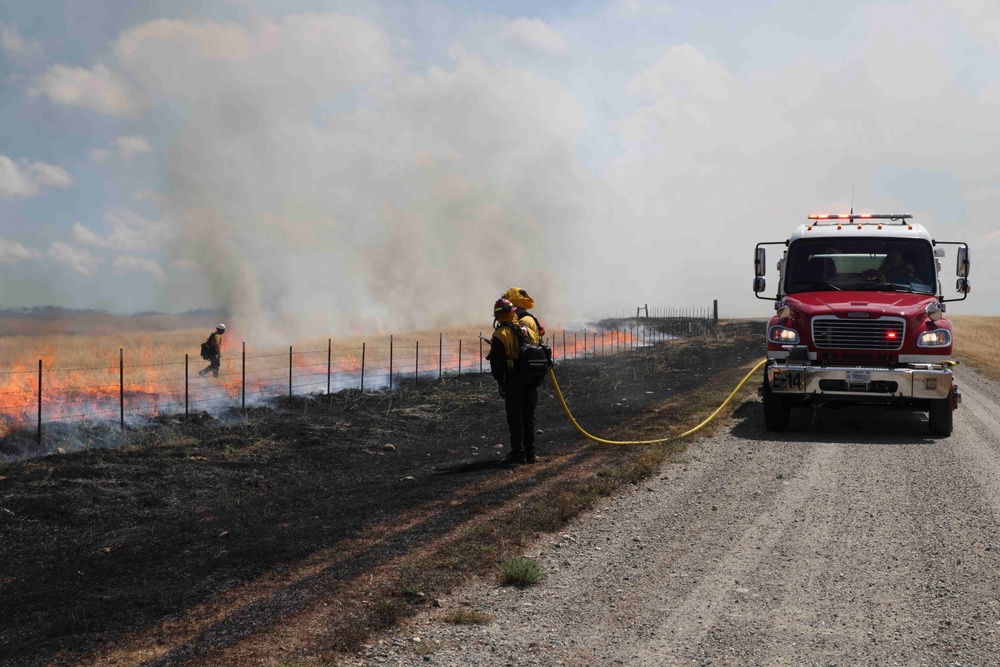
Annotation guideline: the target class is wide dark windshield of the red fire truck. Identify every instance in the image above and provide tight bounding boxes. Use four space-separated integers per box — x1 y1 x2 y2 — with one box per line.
785 238 935 294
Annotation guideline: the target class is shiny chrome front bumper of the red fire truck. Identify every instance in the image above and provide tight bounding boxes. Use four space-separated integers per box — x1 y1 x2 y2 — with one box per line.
767 363 957 403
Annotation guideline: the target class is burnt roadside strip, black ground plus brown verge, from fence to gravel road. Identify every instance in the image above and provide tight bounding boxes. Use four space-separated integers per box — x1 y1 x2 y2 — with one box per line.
0 322 762 666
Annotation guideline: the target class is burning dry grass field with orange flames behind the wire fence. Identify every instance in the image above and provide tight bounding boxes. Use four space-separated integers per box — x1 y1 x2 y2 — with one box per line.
0 309 646 446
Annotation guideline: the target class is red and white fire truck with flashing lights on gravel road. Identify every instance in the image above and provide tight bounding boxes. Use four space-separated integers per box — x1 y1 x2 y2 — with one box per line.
753 212 971 436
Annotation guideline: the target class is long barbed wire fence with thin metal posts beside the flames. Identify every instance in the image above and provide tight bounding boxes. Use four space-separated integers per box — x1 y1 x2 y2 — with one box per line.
0 306 718 446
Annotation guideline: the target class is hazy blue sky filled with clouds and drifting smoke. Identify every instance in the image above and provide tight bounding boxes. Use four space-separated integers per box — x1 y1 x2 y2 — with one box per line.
0 0 1000 336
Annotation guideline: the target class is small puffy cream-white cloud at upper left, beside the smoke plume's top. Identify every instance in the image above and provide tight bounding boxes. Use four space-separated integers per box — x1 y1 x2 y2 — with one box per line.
32 64 148 118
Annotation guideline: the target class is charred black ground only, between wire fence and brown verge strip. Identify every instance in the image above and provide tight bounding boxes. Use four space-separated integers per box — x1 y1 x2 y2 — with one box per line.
0 322 762 666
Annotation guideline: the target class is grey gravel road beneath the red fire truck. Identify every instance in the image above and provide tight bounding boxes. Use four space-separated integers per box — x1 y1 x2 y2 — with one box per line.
362 367 1000 666
